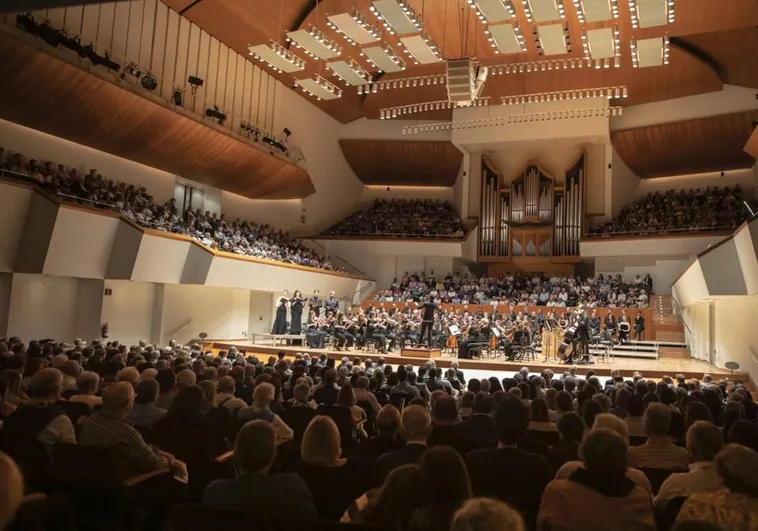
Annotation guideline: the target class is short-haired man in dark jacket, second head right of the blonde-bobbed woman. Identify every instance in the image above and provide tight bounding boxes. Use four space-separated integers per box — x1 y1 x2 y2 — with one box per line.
373 406 431 487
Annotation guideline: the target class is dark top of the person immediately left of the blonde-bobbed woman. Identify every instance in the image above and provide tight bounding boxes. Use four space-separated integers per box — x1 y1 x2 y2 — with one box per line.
203 473 317 519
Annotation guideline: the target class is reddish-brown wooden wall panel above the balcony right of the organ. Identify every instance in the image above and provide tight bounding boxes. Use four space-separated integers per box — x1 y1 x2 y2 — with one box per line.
612 111 758 178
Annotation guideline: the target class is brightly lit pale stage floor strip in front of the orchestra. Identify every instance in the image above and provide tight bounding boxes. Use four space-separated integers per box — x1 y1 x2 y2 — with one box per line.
205 340 749 381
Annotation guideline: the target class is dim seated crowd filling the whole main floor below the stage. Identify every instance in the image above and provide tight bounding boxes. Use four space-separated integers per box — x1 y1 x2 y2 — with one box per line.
0 338 758 531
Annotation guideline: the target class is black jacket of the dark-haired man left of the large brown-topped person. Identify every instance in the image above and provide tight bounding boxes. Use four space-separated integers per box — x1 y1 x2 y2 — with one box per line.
466 448 552 529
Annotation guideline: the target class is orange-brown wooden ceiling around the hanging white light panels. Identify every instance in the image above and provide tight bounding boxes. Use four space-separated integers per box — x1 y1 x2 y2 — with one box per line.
163 0 758 123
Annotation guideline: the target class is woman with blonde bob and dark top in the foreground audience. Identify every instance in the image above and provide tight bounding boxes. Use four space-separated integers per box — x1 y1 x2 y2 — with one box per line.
299 415 363 521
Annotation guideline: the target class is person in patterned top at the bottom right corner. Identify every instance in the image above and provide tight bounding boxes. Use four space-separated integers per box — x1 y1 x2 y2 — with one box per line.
677 444 758 531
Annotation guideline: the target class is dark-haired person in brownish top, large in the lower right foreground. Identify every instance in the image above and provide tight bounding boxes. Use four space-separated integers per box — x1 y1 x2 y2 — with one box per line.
537 428 656 531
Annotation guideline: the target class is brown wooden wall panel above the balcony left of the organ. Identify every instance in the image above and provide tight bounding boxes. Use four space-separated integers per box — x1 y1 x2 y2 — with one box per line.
340 139 463 186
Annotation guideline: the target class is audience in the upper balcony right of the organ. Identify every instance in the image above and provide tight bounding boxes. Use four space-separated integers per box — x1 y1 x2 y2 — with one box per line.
589 186 746 236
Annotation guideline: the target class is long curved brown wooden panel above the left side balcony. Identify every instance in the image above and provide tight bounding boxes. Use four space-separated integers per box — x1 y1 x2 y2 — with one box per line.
0 33 315 199
